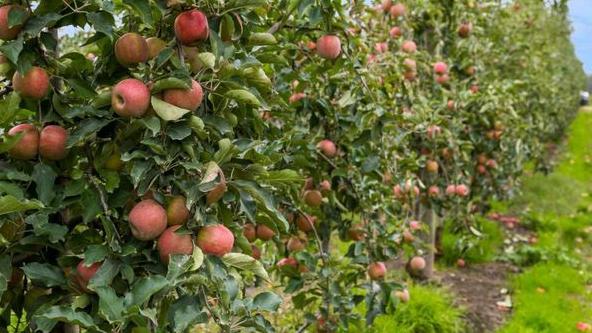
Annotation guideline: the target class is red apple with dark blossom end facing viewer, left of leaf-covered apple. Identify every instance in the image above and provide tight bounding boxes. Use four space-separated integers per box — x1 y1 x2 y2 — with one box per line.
111 79 150 118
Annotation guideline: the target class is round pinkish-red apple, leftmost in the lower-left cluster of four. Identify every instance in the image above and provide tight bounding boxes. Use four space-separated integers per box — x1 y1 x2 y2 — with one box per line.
129 199 167 241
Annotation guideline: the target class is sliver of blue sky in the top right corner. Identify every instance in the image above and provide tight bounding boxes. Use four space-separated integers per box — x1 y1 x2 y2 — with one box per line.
569 0 592 74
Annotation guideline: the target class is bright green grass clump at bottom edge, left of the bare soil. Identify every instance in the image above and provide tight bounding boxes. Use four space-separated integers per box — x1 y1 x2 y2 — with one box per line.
362 285 465 333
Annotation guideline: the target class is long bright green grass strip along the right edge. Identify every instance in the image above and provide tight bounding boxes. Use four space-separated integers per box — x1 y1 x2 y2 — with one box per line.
499 108 592 333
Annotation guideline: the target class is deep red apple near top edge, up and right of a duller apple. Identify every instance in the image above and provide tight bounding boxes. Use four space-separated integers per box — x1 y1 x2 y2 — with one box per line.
175 9 210 45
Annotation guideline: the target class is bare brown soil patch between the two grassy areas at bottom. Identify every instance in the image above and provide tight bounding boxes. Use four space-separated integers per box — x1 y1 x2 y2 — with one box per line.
435 262 518 333
